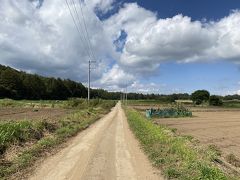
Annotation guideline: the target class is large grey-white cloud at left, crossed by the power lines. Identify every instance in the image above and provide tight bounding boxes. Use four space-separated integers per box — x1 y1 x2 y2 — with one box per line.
0 0 118 82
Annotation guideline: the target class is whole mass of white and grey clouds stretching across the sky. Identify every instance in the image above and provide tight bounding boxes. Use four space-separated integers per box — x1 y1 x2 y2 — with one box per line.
0 0 240 90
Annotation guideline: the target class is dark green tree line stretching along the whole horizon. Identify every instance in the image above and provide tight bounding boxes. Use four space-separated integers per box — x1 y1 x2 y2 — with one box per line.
0 65 240 102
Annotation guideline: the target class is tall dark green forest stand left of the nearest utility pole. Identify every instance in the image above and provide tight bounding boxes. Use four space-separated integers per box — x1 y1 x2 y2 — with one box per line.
0 65 87 100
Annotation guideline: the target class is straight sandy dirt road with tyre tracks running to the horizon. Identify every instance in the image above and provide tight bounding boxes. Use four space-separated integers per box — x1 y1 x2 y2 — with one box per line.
30 103 162 180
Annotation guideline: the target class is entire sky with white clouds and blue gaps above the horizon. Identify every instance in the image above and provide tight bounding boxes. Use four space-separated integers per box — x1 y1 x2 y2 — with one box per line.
0 0 240 95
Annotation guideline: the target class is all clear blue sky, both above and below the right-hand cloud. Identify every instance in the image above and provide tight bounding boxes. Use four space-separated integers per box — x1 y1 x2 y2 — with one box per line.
102 0 240 95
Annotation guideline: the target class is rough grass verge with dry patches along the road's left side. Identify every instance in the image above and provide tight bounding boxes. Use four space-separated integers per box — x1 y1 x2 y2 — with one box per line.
0 100 116 179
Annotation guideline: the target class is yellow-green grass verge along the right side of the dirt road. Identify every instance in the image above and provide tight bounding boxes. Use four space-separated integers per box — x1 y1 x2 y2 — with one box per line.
125 109 237 180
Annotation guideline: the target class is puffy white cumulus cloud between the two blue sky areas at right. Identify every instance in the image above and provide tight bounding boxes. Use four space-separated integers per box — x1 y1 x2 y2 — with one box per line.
106 3 240 74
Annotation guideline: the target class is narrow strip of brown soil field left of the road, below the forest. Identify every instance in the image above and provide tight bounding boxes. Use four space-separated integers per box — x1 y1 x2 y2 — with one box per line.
0 107 72 121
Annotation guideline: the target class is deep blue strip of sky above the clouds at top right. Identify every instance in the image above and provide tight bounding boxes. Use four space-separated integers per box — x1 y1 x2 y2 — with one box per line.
123 0 240 20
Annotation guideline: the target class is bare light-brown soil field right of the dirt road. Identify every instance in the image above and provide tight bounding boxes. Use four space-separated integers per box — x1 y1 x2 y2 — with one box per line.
156 109 240 158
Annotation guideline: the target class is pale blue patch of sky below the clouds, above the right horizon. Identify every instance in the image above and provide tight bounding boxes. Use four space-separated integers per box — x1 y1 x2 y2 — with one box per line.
143 61 240 94
